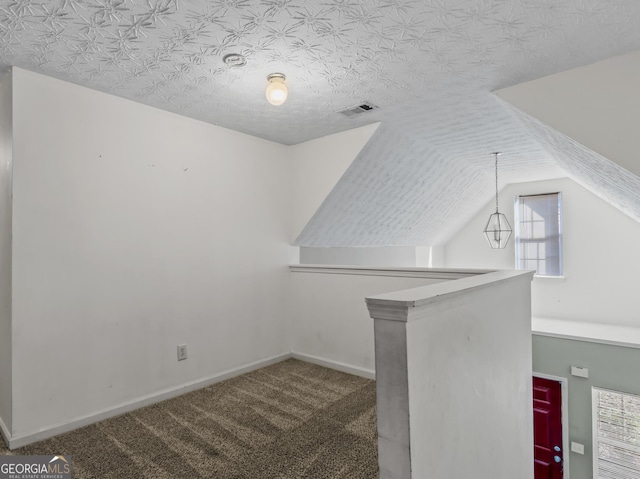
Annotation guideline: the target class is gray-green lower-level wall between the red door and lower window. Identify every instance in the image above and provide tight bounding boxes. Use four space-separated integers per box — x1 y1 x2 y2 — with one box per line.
533 335 640 479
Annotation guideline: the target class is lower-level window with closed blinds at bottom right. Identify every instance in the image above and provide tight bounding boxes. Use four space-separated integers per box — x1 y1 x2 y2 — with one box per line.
593 388 640 479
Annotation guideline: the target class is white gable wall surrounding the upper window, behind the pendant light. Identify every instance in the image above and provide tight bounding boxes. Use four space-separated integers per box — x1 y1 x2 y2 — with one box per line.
445 179 640 325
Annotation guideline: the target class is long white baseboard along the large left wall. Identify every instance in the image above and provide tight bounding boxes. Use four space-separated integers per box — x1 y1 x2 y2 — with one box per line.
0 353 290 449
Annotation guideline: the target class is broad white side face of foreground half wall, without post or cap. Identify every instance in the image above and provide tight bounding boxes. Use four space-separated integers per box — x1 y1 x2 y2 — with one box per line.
406 275 533 479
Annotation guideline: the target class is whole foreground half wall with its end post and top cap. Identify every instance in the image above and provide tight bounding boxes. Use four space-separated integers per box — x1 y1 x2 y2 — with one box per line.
366 271 533 479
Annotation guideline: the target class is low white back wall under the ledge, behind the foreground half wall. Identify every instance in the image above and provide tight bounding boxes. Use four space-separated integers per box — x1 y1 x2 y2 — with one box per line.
291 272 442 376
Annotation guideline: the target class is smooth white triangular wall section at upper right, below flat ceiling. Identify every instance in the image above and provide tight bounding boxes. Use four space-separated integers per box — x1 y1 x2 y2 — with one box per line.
496 51 640 176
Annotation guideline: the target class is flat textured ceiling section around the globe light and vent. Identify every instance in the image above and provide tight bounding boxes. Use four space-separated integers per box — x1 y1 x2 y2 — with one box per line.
0 0 640 144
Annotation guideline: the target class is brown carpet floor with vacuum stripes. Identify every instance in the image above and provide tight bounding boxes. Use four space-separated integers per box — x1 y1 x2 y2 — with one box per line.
0 359 378 479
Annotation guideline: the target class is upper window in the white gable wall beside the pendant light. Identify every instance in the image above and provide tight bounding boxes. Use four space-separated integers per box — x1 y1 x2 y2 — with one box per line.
515 193 562 276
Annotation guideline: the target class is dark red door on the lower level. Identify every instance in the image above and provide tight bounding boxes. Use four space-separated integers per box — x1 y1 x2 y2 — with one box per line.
533 377 563 479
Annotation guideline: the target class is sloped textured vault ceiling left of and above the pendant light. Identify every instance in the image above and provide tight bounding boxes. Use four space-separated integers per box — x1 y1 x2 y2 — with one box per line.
296 93 567 246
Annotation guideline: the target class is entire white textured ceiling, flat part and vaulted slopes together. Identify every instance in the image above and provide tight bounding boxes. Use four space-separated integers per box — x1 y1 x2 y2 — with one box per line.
0 0 640 246
